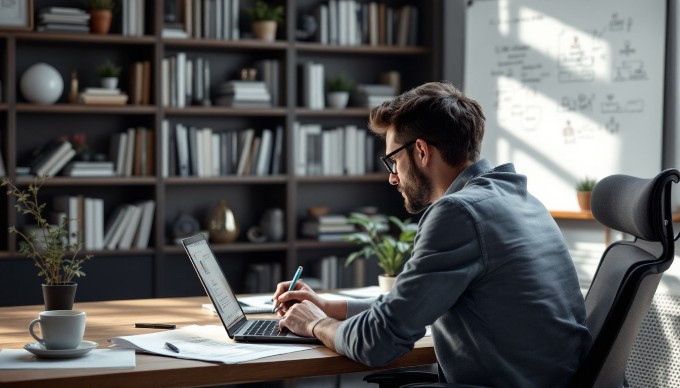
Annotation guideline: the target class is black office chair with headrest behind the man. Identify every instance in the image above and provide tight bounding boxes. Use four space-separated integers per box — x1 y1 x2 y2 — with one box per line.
364 169 680 388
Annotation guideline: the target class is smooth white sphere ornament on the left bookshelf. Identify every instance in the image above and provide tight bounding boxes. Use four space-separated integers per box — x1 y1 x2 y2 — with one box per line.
20 63 64 105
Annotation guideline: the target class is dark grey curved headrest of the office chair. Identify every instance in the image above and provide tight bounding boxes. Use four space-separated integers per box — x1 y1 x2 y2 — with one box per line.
591 169 680 241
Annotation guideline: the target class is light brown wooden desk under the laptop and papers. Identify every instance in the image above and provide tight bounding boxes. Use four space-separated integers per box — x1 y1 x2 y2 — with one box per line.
0 297 436 388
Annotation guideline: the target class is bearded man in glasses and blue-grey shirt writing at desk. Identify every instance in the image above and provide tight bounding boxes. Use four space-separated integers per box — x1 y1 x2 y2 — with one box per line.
274 83 591 388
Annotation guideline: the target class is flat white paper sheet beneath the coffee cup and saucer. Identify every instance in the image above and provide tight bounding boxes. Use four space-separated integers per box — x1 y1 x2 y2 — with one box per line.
0 349 136 369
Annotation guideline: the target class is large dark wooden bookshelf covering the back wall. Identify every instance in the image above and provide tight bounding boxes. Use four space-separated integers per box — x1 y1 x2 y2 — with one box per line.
0 0 443 305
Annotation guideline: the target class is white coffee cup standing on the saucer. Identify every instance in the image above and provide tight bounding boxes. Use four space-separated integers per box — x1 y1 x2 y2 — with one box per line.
28 310 85 350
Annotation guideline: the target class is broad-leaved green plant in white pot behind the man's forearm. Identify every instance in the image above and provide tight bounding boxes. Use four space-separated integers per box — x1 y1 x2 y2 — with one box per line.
345 213 418 291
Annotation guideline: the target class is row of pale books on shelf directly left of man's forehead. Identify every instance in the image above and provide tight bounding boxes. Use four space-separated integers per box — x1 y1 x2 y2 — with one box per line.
293 122 375 176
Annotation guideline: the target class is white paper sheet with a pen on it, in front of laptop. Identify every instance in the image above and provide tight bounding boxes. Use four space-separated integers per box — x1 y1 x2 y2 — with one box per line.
111 325 320 364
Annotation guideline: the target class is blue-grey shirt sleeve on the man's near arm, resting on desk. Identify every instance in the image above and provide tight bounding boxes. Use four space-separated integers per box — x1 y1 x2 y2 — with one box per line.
335 202 484 365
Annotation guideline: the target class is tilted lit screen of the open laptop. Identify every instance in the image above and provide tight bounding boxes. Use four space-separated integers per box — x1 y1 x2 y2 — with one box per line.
182 235 246 334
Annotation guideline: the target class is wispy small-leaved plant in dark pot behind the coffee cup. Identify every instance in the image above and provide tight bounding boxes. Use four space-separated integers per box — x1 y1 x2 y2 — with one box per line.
0 178 92 310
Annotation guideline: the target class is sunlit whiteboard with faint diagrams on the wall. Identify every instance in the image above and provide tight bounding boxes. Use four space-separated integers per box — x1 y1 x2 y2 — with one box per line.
464 0 666 210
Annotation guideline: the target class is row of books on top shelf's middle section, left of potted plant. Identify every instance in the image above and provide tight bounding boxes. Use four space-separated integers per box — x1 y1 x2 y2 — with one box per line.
162 0 240 40
